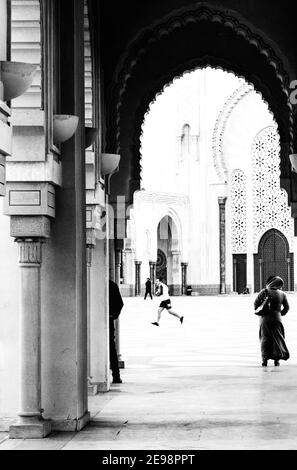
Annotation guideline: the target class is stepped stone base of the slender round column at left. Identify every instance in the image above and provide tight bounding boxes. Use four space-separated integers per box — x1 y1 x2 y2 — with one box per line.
9 416 52 439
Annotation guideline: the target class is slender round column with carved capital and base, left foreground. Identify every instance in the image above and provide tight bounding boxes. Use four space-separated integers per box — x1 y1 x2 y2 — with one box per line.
9 238 51 439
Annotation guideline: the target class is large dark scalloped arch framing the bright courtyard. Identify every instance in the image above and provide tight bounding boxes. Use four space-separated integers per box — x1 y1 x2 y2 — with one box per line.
107 4 294 203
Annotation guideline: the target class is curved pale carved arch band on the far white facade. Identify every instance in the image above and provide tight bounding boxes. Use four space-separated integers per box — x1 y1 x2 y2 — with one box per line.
212 83 254 183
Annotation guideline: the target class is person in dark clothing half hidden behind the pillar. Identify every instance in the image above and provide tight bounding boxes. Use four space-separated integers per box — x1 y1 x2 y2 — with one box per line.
109 280 124 384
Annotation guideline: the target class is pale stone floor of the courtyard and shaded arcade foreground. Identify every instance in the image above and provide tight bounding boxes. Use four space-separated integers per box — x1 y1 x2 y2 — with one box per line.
0 294 297 450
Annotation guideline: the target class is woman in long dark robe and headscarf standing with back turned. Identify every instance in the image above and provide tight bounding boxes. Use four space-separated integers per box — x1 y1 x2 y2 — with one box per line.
255 276 290 367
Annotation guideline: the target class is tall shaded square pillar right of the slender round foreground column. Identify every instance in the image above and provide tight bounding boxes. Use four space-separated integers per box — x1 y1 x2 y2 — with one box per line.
42 0 90 431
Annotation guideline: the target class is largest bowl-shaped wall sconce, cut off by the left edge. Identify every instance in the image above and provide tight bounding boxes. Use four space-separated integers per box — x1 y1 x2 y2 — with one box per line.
0 60 37 101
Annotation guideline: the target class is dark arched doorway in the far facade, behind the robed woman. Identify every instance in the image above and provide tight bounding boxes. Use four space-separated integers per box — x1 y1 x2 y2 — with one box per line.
254 229 294 291
